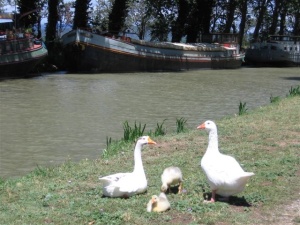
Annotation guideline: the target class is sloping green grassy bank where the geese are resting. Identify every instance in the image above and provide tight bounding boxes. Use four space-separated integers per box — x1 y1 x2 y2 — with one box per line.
0 96 300 224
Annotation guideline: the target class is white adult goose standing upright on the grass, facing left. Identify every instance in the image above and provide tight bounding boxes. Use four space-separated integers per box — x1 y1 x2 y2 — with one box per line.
197 120 254 202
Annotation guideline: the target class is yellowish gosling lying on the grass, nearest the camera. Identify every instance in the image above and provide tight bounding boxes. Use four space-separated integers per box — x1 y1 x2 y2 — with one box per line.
147 192 171 212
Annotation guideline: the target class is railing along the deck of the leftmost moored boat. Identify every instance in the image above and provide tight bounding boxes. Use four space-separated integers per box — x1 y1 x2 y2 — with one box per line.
0 36 42 55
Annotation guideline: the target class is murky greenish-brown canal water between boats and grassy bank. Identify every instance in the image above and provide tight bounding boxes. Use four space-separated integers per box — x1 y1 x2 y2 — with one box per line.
0 68 300 177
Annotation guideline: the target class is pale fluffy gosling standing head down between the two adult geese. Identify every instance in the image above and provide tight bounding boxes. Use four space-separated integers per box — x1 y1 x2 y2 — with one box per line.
160 166 183 194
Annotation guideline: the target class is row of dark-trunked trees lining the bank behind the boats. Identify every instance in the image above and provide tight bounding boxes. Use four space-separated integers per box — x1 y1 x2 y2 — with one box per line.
0 0 300 45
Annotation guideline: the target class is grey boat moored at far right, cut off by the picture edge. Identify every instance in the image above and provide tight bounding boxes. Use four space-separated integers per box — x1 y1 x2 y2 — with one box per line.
245 35 300 67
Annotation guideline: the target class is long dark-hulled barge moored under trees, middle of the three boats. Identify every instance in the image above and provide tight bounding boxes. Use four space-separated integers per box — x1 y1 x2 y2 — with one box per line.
62 29 244 73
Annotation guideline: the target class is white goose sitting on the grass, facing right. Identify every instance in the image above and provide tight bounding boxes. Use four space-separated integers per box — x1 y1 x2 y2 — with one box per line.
99 136 156 198
